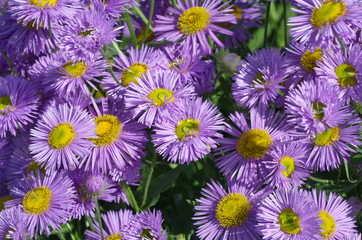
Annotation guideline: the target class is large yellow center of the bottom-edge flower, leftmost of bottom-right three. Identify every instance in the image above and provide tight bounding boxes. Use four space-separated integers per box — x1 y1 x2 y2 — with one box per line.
215 193 251 227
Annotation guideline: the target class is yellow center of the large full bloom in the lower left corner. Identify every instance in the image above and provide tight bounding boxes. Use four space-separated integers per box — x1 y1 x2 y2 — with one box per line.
23 186 53 214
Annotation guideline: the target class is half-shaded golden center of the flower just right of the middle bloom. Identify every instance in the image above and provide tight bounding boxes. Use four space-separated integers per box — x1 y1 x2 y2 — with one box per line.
236 129 273 159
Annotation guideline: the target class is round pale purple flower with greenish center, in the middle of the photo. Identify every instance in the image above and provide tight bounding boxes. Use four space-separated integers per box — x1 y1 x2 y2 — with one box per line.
152 98 224 164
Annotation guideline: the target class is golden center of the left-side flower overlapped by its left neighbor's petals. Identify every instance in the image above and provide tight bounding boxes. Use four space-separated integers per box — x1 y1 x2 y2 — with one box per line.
89 114 122 146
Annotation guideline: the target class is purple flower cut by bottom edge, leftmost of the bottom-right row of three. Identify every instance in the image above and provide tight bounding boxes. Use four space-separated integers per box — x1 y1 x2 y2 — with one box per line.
192 180 265 240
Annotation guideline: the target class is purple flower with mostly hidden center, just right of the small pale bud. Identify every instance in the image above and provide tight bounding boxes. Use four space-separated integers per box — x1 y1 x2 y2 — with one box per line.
232 48 290 107
